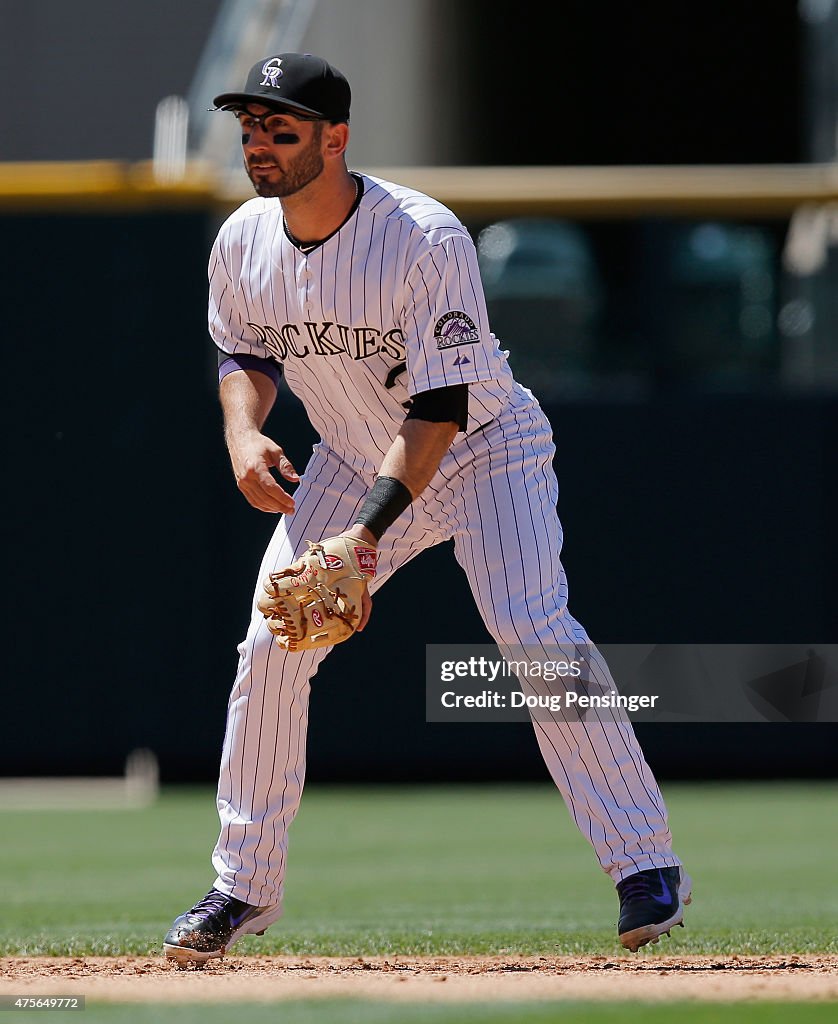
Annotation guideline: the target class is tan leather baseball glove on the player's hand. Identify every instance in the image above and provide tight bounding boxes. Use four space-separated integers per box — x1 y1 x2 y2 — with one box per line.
256 537 376 651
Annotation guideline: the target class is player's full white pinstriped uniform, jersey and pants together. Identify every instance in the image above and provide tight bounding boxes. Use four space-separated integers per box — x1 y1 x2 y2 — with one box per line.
202 176 678 905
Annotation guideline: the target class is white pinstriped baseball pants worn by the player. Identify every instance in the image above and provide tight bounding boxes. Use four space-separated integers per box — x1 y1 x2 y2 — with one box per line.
212 407 680 906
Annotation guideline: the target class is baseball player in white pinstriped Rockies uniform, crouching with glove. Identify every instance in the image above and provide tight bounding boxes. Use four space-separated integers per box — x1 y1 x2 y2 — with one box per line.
164 53 690 965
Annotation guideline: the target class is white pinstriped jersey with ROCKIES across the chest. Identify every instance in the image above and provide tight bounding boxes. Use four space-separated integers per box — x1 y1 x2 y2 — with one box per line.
209 175 533 473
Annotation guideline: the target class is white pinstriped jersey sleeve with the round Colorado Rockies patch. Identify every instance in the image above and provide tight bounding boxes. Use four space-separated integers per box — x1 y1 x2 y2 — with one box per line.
405 228 504 394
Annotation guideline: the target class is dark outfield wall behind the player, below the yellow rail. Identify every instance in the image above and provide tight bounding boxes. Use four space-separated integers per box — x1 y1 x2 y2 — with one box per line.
0 183 838 781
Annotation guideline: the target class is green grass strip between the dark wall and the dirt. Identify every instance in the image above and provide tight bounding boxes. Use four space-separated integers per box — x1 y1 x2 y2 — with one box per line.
0 783 838 954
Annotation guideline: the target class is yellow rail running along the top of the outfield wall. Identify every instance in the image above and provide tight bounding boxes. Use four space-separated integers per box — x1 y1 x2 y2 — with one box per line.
0 161 838 218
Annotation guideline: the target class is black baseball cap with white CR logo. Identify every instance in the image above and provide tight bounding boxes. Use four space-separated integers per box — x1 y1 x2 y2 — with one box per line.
213 53 351 121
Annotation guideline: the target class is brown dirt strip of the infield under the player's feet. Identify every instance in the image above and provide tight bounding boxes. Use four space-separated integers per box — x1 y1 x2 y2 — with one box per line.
0 954 838 1002
